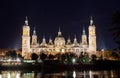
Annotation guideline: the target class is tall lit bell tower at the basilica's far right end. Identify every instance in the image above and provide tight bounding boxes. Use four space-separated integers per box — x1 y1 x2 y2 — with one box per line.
89 16 97 52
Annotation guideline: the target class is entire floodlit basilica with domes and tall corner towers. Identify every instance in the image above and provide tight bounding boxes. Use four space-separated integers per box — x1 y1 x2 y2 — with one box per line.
22 17 97 59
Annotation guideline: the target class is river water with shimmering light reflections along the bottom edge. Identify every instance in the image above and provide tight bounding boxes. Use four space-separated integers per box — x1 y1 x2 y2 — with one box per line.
0 70 120 78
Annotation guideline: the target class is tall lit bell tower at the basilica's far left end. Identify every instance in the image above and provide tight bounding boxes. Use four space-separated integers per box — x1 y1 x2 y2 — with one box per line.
22 17 30 59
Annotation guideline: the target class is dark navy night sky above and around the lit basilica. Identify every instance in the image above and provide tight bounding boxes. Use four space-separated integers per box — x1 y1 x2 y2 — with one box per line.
0 0 120 49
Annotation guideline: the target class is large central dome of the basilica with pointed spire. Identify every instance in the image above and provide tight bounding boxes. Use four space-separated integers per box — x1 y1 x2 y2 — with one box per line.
54 29 65 47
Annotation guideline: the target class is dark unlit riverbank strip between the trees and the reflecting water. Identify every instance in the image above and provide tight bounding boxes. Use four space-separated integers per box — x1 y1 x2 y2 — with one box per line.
0 61 120 71
